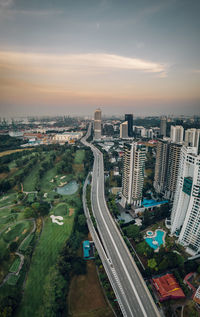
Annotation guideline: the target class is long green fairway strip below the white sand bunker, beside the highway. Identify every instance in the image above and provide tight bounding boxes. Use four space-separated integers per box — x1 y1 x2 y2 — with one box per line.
17 216 74 317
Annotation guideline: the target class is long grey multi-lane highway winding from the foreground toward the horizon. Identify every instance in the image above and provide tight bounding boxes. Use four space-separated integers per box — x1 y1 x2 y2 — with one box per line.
82 125 160 317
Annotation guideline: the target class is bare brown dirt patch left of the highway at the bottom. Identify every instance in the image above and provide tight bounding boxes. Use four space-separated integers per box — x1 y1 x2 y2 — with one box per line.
69 261 114 317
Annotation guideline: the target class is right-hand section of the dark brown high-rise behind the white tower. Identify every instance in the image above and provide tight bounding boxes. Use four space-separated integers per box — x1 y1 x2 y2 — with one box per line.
164 143 182 200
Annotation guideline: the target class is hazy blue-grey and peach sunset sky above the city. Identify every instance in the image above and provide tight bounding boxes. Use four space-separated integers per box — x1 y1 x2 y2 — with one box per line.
0 0 200 117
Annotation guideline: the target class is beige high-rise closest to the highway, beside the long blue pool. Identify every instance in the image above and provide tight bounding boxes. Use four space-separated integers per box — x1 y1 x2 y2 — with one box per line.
121 142 146 207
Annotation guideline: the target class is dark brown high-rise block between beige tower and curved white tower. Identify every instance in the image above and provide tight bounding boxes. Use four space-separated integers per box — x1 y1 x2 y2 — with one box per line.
153 138 182 200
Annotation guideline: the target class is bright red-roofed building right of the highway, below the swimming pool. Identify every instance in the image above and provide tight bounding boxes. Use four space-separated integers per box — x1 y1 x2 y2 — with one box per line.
152 274 185 302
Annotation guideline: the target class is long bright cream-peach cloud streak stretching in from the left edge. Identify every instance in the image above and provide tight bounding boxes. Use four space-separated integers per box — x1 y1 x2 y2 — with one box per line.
0 52 168 77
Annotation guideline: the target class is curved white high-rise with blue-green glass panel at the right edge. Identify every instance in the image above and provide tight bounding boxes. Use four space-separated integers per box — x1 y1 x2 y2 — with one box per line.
171 146 200 255
